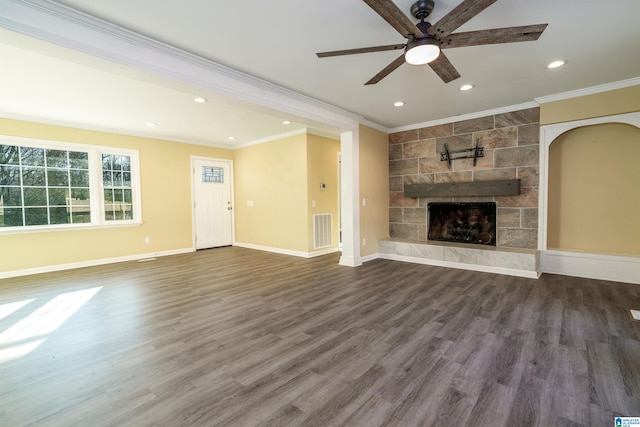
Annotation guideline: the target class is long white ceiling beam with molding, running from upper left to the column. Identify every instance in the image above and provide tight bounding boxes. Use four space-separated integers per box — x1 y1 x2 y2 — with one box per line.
0 0 362 130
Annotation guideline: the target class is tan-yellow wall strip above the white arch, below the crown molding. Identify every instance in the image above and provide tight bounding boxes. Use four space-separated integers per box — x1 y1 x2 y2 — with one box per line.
540 85 640 125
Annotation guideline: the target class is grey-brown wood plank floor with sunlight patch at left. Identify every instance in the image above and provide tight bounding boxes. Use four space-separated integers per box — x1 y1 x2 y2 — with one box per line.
0 247 640 427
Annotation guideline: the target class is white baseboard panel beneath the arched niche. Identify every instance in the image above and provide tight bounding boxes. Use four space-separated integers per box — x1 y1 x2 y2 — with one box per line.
541 250 640 284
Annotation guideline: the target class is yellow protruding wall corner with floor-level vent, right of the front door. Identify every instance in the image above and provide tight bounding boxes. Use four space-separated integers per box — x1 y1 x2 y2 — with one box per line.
234 134 340 254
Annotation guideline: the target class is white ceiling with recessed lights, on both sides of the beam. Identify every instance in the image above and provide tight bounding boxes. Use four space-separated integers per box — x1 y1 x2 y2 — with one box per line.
0 0 640 146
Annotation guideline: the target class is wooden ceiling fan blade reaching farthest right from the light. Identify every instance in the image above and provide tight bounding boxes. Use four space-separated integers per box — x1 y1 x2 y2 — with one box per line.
441 24 548 49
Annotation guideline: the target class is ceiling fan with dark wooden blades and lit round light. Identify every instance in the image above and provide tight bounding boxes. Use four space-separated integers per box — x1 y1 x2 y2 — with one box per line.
316 0 548 85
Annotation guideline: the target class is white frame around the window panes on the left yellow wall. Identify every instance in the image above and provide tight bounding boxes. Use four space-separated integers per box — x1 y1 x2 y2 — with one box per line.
0 135 142 235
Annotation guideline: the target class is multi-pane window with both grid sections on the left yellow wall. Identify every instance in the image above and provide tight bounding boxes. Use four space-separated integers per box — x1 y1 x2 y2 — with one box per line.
0 137 141 231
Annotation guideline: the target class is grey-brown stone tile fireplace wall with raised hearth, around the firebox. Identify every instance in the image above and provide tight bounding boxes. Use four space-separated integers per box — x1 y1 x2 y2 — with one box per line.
379 108 540 277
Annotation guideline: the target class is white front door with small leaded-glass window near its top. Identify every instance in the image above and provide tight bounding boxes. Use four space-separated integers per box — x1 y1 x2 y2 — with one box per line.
193 158 233 249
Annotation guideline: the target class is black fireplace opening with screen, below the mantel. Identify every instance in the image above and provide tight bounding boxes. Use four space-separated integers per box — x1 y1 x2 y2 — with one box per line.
427 202 496 246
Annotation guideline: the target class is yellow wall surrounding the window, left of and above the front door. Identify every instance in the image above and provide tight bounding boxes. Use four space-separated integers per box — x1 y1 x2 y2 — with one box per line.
0 119 232 272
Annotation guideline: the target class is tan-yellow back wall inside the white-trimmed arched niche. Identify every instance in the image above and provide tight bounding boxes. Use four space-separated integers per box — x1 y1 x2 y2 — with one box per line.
547 123 640 255
